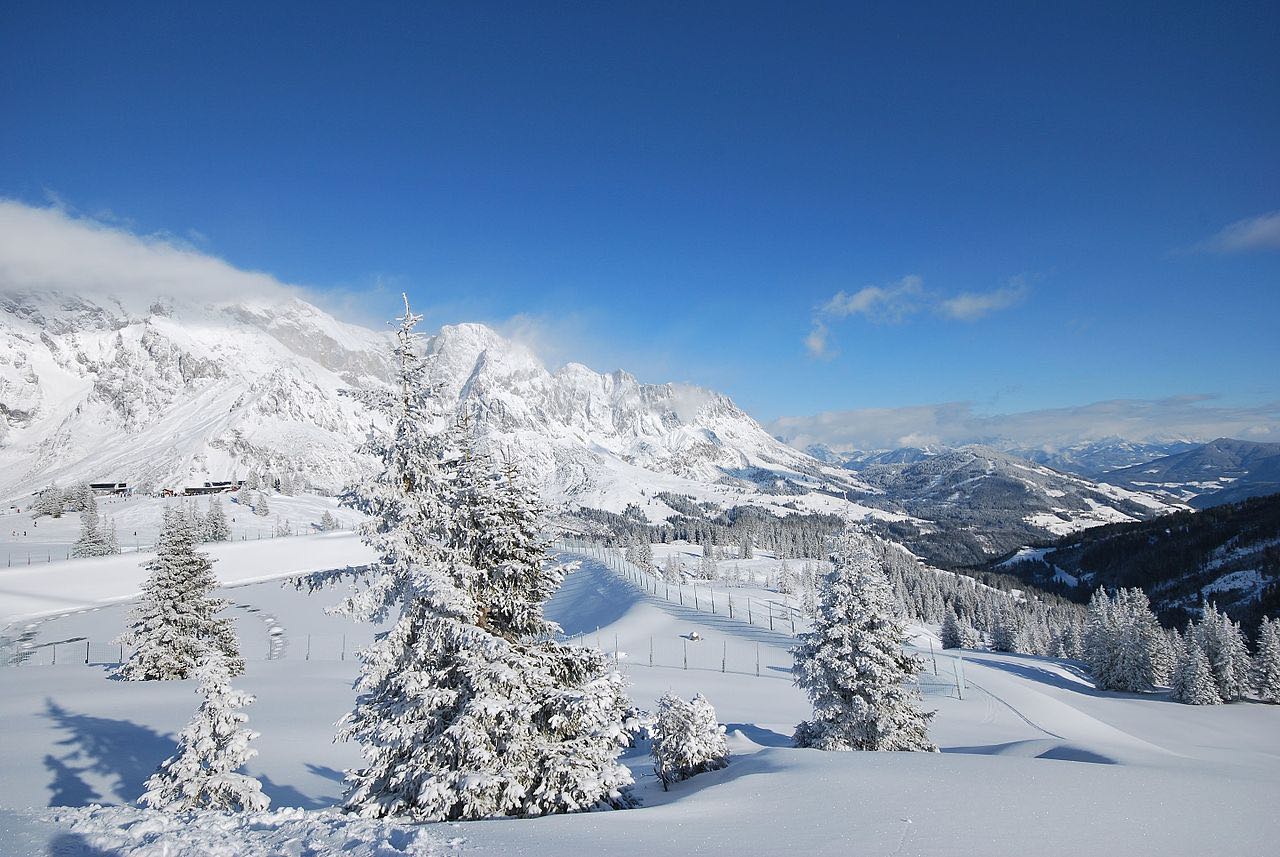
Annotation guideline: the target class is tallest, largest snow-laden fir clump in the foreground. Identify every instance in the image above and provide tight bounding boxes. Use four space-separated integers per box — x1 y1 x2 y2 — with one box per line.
338 299 631 821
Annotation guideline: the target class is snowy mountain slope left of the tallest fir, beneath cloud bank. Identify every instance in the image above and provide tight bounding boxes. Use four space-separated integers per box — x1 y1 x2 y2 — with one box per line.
0 290 387 499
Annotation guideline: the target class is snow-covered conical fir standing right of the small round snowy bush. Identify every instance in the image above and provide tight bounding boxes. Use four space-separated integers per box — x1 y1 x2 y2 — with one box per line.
792 530 937 751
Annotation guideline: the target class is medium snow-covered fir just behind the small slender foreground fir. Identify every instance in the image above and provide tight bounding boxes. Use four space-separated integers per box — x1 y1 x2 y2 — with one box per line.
118 508 244 682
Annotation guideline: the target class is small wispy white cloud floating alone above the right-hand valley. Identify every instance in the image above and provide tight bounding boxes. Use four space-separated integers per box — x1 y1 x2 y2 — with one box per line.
804 274 1029 358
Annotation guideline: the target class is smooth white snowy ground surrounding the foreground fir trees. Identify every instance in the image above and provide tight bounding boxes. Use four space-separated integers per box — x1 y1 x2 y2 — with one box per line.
0 547 1280 857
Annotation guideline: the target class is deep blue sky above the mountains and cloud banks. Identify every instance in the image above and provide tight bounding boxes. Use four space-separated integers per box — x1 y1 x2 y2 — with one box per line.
0 3 1280 442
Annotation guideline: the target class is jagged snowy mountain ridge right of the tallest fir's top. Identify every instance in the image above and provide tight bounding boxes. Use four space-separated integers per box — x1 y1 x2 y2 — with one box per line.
426 324 880 522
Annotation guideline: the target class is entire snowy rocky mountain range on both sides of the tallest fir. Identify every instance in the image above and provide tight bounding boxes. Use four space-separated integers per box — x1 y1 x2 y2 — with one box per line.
0 292 870 519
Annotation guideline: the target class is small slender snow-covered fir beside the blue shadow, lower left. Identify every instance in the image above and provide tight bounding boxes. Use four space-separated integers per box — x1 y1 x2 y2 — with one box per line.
140 649 271 812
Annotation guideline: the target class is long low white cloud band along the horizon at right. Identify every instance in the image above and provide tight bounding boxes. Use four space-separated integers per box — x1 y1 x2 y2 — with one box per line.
769 395 1280 452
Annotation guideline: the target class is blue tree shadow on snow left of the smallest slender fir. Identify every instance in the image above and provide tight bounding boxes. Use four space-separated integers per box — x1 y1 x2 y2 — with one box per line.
45 698 175 806
